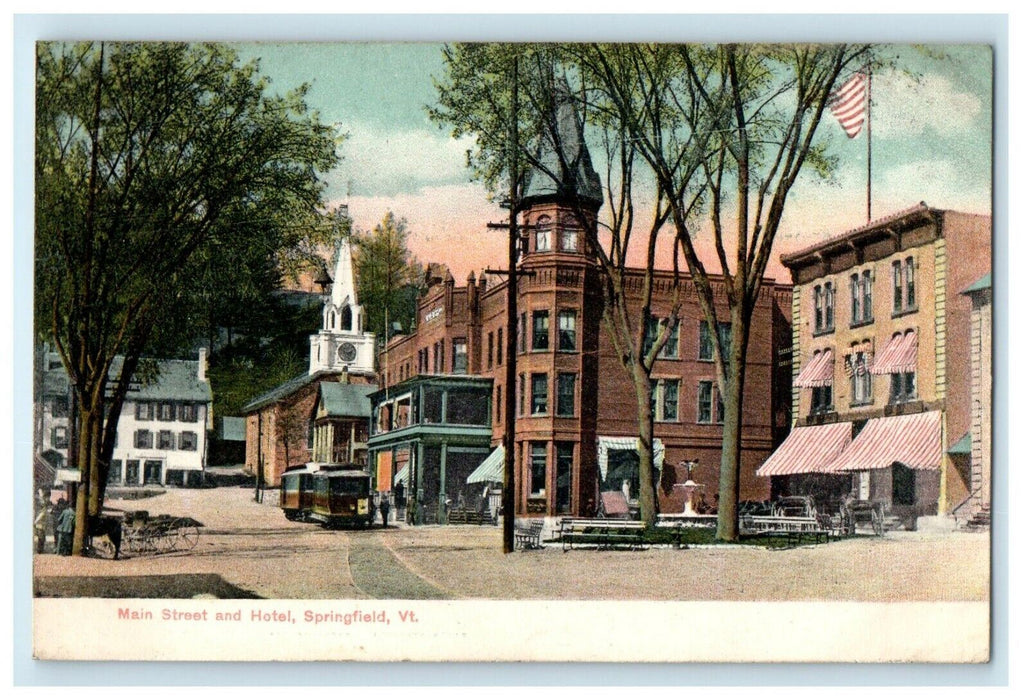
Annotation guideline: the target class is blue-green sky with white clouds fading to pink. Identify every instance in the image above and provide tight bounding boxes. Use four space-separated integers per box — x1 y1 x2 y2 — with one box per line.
213 43 993 280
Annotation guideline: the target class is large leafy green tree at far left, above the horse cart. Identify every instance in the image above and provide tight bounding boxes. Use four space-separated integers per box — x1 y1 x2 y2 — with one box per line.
36 43 338 553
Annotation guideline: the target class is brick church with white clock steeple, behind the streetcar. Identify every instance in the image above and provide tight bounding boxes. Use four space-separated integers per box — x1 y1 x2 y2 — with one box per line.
243 240 376 487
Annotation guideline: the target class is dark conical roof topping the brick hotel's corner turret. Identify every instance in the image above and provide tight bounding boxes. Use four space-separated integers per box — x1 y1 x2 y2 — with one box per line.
519 76 604 209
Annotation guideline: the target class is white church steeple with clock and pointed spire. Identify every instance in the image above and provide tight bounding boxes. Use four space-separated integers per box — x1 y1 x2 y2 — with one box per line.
308 236 376 375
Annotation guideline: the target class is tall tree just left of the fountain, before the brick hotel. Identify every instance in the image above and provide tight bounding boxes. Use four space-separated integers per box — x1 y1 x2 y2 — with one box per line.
430 44 701 525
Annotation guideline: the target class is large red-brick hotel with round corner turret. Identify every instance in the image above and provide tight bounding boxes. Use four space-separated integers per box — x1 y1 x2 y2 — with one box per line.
372 84 790 516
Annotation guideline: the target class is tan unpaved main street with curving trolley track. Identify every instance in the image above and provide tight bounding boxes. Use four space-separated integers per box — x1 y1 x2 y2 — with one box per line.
34 487 990 601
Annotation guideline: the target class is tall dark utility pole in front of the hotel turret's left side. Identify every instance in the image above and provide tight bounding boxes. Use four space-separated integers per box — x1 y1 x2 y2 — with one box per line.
503 55 519 554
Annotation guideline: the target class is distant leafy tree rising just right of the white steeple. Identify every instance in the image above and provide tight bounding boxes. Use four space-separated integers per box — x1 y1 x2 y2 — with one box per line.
353 211 421 337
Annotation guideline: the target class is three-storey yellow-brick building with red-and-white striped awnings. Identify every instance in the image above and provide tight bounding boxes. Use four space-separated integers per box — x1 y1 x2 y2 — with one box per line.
759 203 991 524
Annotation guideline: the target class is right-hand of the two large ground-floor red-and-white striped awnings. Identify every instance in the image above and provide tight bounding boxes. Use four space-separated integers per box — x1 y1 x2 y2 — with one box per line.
826 411 943 471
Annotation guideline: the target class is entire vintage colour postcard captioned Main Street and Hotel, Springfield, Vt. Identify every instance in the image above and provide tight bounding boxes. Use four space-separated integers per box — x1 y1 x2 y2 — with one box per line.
28 34 994 663
